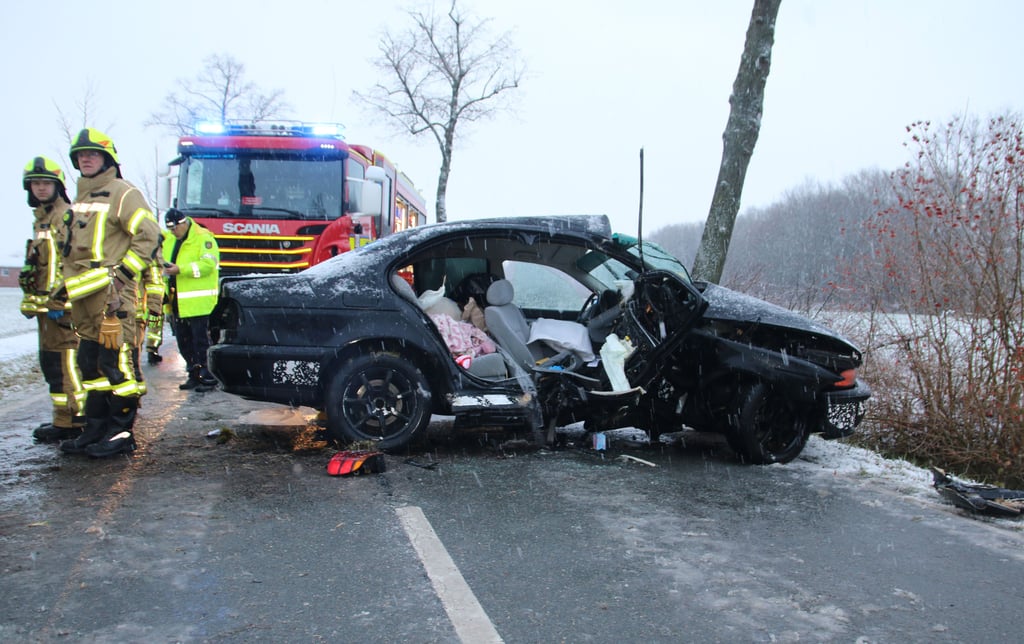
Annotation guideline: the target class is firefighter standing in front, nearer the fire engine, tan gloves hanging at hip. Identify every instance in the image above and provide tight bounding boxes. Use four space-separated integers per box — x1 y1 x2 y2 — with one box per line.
47 128 160 458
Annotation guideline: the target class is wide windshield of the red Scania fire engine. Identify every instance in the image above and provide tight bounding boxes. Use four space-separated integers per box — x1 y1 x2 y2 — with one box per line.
177 155 344 221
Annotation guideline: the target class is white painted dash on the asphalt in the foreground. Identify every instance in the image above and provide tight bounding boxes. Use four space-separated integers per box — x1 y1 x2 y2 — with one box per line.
395 506 504 644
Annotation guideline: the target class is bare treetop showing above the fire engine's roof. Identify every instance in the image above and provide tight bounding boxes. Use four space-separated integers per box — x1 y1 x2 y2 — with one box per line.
145 53 291 135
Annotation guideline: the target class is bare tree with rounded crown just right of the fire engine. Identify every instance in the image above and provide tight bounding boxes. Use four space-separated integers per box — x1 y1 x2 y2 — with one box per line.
353 0 523 221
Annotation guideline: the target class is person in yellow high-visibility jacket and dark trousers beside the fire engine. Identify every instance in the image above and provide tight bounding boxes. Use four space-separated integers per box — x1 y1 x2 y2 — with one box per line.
164 208 220 391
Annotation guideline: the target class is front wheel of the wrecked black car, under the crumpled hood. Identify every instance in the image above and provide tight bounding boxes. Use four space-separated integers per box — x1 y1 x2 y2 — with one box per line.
726 383 813 465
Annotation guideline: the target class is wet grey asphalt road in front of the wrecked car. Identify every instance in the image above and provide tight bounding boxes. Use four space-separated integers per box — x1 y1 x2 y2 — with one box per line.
0 339 1024 642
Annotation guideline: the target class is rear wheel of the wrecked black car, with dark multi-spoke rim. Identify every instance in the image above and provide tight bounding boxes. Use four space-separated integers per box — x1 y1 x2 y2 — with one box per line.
326 353 431 449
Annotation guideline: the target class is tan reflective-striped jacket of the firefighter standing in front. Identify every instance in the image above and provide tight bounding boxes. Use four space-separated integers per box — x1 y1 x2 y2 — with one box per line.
63 167 161 296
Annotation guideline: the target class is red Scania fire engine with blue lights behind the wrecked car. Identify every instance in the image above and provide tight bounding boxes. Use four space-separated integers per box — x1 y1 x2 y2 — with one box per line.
161 121 426 275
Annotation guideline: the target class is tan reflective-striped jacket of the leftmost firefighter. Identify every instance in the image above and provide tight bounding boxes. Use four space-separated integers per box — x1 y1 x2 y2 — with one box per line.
22 195 68 315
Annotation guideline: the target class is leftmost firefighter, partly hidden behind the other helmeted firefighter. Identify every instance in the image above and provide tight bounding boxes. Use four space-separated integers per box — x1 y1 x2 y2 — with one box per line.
18 157 85 442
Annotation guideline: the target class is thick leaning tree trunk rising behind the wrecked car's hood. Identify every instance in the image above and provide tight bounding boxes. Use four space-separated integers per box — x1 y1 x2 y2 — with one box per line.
692 0 781 283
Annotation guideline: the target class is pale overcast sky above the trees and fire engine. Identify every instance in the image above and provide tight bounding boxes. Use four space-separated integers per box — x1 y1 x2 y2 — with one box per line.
0 0 1024 265
